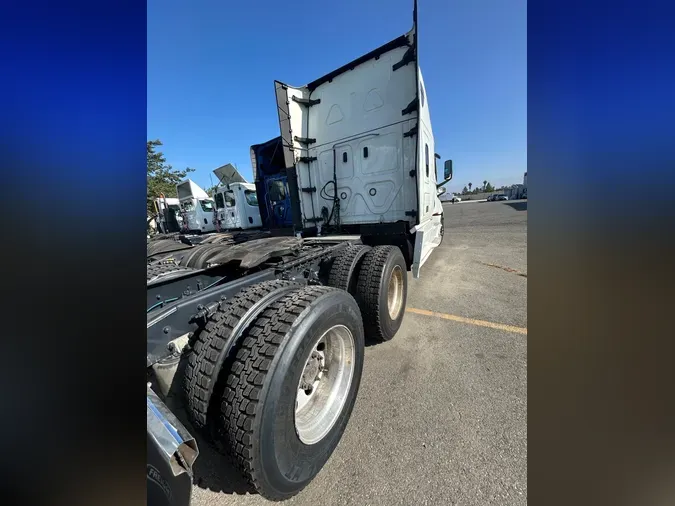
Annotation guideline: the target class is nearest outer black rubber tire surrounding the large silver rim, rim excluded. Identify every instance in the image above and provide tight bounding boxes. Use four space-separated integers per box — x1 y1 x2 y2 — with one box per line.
221 286 364 501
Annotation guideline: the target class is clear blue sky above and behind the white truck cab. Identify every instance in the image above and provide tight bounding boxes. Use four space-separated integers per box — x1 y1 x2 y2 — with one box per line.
147 0 527 191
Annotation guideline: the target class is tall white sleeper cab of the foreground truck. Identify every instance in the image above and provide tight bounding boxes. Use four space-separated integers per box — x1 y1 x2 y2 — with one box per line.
275 3 447 277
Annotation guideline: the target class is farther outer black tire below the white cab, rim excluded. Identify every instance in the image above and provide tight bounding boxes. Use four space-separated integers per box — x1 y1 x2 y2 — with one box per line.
356 246 408 341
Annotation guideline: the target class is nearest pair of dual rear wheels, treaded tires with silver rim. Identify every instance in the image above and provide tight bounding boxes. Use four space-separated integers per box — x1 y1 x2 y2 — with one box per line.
185 281 364 501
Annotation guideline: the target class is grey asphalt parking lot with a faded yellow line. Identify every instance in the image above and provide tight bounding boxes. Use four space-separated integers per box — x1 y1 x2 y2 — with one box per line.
192 201 527 506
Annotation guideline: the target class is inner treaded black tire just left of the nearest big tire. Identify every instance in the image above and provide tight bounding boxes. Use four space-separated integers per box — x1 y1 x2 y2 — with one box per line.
183 279 300 429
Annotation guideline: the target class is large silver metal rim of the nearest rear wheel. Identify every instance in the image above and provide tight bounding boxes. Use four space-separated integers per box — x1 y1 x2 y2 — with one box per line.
295 325 356 445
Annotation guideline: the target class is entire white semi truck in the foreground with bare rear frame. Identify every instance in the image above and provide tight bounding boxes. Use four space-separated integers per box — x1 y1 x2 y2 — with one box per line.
147 0 452 500
